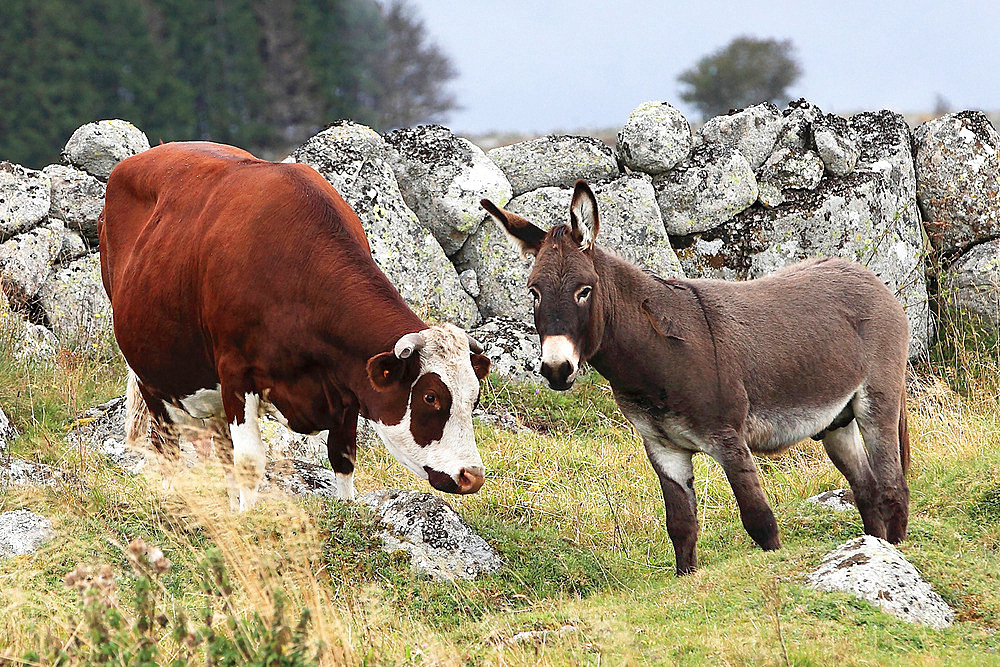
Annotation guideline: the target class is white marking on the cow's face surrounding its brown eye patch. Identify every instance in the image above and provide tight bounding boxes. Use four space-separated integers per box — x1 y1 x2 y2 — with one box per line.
374 324 483 490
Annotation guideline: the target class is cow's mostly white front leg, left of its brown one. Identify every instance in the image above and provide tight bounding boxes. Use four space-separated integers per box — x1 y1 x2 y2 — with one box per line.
222 387 267 512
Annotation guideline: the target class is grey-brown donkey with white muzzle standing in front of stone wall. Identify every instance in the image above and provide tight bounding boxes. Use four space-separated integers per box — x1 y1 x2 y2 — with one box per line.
481 181 909 575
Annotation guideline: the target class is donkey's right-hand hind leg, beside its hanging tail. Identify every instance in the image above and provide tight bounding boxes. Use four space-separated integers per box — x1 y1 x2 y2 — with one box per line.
854 390 910 544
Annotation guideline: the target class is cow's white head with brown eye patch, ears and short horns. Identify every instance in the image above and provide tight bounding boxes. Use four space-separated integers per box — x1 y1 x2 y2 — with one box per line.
368 324 490 493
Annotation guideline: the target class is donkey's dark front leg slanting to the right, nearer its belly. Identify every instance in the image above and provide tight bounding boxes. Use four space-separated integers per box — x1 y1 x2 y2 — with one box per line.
711 431 781 551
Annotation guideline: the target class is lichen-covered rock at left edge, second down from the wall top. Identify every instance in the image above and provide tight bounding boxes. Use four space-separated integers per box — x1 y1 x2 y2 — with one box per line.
0 223 66 308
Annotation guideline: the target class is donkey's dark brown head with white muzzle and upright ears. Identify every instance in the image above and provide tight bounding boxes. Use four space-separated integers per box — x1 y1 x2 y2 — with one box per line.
480 181 604 390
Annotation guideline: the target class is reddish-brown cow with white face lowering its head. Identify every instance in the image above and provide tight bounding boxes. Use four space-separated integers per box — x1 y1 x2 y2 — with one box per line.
98 142 489 509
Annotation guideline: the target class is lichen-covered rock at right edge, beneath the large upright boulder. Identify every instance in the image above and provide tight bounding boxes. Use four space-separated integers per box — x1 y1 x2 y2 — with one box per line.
938 239 1000 325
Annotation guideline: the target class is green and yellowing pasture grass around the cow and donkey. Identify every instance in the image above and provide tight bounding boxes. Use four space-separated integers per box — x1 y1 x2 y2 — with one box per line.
0 312 1000 665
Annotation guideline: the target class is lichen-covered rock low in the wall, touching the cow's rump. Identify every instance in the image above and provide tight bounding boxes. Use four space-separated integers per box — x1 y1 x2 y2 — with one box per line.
38 254 113 353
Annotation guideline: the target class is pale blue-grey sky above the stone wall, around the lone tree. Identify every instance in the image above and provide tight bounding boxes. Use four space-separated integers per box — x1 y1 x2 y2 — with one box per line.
411 0 1000 133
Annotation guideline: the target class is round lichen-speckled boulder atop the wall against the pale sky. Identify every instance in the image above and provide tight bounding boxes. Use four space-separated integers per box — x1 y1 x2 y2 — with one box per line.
618 102 692 174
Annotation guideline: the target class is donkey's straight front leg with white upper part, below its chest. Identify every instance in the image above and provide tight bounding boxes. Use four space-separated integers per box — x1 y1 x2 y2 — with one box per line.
643 438 698 576
